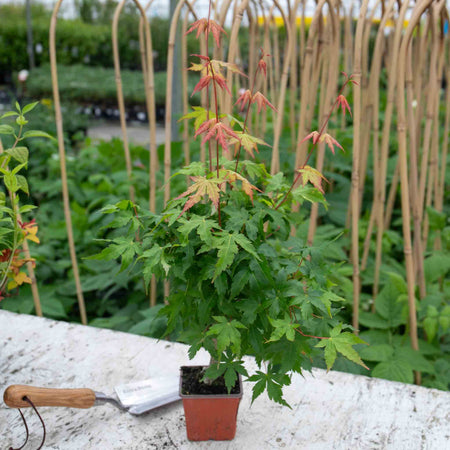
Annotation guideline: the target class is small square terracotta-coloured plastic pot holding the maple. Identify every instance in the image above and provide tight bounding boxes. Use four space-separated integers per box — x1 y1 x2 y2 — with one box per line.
180 366 243 441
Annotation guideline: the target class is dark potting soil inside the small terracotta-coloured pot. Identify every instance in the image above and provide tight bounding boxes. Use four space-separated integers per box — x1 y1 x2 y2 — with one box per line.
181 366 240 395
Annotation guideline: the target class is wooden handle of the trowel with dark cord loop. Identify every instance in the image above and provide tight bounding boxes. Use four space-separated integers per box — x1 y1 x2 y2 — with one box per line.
3 384 95 408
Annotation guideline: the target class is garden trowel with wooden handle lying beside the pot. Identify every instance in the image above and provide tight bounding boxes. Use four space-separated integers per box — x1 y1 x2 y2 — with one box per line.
3 376 180 415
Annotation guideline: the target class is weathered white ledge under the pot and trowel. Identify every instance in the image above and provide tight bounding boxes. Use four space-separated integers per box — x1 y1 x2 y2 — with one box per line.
0 311 450 450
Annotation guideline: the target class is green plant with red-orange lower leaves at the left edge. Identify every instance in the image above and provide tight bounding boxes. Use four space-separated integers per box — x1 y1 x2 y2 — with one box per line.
0 102 50 304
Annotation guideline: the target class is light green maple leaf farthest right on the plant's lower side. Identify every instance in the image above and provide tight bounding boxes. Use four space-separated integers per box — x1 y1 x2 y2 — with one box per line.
316 325 368 370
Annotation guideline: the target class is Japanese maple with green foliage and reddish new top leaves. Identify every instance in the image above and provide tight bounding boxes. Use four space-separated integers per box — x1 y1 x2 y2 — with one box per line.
95 14 364 405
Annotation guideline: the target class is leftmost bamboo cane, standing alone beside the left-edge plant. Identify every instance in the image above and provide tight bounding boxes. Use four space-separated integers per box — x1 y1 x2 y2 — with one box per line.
49 0 87 325
